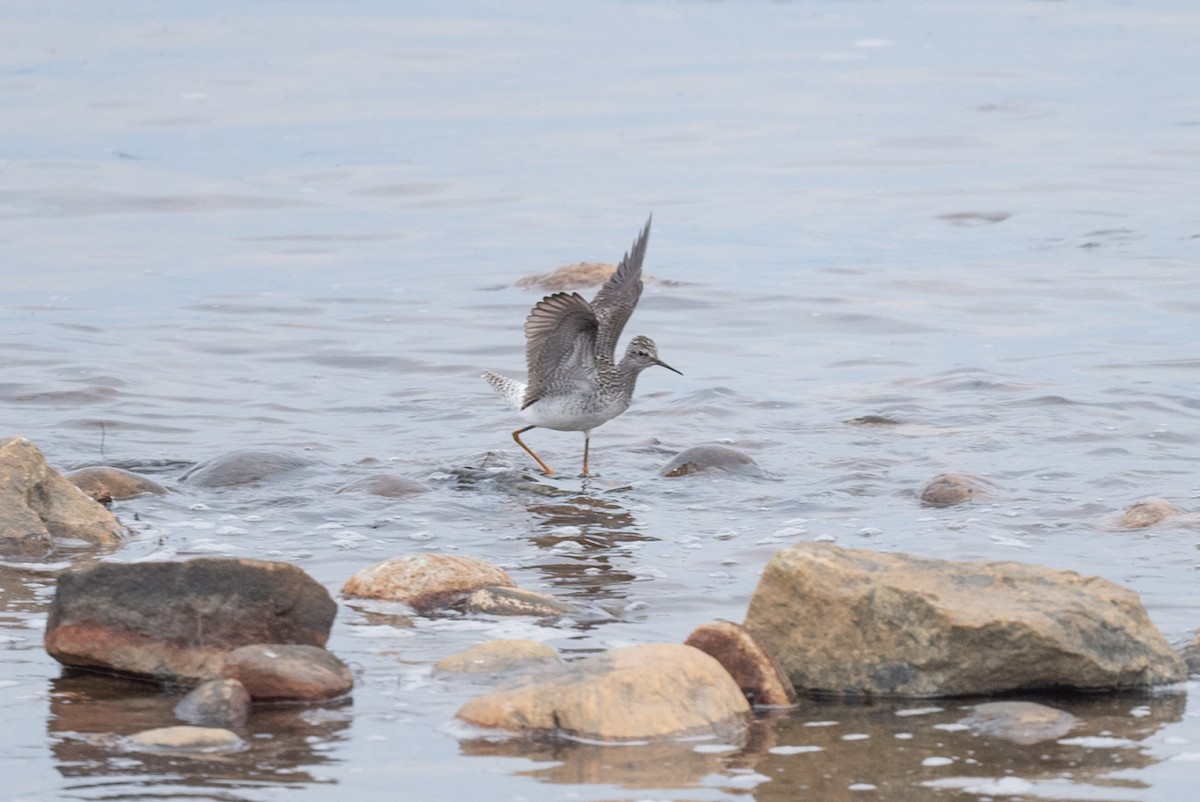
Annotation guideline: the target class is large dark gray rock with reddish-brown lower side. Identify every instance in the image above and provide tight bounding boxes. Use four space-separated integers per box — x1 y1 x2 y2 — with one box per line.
44 557 337 684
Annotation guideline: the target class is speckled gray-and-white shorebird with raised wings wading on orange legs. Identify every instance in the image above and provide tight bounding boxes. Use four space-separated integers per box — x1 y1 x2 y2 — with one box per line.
484 220 683 475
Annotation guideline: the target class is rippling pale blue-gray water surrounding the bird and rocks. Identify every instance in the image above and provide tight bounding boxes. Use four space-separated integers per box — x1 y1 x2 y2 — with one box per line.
0 0 1200 802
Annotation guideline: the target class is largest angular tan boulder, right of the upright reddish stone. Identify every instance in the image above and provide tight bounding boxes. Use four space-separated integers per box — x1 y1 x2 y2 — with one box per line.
745 543 1187 696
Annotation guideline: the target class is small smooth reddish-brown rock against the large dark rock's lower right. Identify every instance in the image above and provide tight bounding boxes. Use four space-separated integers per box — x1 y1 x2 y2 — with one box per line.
222 644 354 701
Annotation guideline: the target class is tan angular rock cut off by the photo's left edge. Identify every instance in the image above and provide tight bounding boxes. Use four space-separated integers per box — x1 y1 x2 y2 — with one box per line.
0 437 125 547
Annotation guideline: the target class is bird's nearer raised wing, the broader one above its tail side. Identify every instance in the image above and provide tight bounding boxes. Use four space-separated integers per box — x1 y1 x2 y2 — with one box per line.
521 293 598 409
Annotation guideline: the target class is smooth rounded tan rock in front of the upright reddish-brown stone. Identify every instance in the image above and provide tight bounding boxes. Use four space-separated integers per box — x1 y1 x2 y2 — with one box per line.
457 644 750 741
